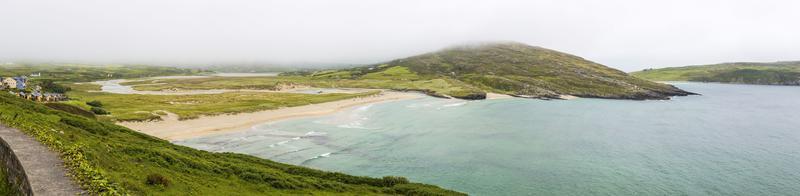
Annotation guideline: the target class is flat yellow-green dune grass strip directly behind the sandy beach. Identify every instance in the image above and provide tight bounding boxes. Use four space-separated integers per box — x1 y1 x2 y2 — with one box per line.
65 84 378 121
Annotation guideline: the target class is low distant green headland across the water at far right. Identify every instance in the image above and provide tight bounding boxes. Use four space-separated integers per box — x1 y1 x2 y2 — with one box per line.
631 61 800 85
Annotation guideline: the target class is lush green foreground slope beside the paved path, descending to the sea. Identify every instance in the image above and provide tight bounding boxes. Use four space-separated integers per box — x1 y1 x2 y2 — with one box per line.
0 94 459 195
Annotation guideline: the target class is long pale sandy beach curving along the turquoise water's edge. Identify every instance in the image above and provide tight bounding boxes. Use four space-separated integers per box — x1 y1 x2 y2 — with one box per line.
118 91 424 141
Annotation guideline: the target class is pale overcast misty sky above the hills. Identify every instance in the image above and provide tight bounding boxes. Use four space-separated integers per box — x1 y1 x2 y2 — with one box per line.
0 0 800 71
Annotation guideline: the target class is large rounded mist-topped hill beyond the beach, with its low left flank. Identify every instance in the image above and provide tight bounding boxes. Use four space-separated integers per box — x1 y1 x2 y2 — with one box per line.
285 42 693 99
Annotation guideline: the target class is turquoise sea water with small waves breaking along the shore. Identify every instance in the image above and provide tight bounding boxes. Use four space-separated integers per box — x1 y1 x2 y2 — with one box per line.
178 83 800 195
